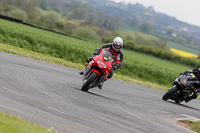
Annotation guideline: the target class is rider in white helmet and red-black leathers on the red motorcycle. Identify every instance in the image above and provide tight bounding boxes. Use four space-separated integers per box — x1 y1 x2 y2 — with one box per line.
79 37 124 89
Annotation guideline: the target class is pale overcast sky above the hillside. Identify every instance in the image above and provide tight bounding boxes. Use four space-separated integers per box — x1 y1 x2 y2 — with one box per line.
113 0 200 27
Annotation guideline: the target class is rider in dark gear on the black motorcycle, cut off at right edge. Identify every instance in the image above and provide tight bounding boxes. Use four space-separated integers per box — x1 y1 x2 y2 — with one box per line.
180 68 200 103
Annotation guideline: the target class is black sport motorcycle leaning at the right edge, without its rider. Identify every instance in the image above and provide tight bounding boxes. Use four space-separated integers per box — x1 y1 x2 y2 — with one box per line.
162 73 199 104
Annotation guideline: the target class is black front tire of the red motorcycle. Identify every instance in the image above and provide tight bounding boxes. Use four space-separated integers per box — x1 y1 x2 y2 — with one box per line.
81 72 98 92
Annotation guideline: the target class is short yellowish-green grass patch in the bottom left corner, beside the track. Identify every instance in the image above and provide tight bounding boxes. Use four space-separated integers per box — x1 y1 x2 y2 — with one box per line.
0 113 55 133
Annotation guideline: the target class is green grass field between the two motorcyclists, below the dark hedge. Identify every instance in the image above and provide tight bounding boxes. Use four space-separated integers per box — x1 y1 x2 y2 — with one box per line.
121 51 192 87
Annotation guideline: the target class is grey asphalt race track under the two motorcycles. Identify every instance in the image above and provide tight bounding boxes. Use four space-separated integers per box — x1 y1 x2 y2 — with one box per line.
0 52 200 133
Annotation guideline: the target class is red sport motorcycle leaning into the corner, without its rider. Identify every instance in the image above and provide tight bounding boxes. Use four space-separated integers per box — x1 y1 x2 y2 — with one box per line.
81 51 113 91
